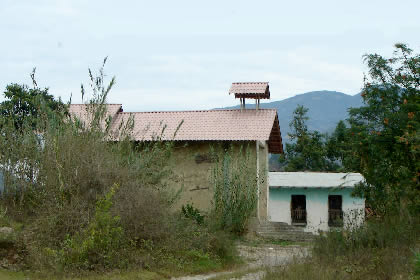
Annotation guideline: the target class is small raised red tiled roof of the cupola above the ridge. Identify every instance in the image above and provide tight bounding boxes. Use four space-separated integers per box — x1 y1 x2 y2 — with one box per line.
229 82 270 99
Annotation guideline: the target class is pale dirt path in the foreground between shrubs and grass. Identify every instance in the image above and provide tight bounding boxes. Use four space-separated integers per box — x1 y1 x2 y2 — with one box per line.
172 244 309 280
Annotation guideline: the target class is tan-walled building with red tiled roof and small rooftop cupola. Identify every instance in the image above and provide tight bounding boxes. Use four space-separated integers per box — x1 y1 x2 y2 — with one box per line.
70 83 283 220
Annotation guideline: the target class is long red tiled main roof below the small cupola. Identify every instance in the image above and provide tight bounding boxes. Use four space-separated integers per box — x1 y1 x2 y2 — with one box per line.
70 105 283 153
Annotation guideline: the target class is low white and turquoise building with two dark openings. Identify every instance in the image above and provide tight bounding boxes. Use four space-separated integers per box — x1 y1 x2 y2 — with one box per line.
268 172 365 233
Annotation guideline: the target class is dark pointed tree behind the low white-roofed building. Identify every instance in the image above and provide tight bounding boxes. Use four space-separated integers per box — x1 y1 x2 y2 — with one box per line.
280 105 338 171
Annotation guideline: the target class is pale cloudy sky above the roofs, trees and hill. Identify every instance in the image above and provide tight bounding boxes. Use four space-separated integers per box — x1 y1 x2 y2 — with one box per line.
0 0 420 111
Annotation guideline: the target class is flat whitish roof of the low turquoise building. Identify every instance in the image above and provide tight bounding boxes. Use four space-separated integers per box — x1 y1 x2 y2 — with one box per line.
268 172 364 188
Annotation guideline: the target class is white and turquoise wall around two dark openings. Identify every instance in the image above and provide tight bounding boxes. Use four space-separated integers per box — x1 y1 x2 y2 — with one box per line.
269 188 365 233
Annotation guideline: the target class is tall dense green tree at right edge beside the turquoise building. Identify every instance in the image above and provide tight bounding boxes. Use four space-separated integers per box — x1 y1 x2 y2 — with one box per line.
349 44 420 213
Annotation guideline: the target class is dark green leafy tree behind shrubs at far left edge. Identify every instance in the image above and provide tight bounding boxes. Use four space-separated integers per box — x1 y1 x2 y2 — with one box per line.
0 72 65 130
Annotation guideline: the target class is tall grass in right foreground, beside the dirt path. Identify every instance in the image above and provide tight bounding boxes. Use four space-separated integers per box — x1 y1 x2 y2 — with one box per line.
266 216 420 280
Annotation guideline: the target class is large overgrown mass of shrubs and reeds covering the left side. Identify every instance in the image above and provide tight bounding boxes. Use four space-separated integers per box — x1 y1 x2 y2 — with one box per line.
0 60 237 279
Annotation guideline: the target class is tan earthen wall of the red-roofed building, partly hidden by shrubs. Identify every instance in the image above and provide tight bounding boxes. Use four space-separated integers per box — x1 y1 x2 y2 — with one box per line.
169 141 268 219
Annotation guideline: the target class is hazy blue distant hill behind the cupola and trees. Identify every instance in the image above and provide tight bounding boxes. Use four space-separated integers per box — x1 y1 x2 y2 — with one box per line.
223 90 363 142
